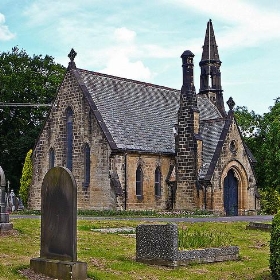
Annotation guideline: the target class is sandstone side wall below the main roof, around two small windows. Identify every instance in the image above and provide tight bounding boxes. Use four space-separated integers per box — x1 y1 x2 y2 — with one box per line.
111 153 174 210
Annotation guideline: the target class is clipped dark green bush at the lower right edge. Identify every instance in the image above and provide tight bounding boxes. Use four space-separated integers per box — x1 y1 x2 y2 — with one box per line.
269 212 280 279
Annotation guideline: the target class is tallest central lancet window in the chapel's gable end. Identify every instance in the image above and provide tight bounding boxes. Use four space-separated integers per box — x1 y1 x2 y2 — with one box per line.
66 107 73 171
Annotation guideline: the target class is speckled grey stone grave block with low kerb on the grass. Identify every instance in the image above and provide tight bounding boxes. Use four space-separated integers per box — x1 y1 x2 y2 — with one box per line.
136 223 239 267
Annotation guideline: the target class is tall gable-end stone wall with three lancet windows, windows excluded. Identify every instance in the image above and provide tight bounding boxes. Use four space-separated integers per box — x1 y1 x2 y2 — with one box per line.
29 71 116 209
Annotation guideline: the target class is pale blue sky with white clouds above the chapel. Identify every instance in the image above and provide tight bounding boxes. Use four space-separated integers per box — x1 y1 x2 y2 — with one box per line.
0 0 280 114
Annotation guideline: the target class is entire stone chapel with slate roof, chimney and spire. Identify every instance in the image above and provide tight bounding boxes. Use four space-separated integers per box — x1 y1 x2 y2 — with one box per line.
29 20 259 215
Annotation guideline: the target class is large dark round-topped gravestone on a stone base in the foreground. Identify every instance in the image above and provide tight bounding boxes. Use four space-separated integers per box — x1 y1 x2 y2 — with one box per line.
30 167 87 280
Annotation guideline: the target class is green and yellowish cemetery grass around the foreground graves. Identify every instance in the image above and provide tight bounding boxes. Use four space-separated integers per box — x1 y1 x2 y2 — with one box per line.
0 219 272 280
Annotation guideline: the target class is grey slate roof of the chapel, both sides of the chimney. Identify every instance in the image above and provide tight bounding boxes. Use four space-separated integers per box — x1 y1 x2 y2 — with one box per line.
75 69 225 176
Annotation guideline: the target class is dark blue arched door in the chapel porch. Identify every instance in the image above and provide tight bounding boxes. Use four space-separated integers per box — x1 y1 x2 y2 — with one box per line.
224 169 238 216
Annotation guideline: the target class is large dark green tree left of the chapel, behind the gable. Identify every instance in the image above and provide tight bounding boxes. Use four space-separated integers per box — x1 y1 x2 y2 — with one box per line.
0 47 65 190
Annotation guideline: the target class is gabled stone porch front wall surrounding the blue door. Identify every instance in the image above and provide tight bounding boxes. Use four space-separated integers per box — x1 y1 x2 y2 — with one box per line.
210 116 259 215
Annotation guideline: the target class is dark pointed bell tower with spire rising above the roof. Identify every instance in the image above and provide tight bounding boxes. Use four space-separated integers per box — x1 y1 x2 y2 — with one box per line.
199 19 226 117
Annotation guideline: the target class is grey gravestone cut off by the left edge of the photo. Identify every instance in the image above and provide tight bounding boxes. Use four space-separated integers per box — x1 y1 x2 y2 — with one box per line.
0 166 13 233
